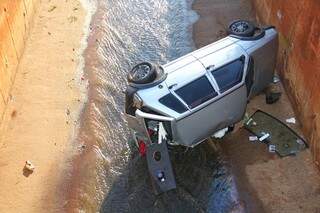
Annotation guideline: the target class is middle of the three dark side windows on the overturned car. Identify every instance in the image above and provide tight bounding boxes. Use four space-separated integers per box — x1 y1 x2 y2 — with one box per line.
175 76 217 109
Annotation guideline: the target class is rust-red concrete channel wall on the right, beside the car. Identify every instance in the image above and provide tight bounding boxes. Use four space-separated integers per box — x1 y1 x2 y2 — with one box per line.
252 0 320 167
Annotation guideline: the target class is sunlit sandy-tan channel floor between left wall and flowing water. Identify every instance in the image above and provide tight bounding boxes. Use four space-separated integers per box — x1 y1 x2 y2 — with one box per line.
0 0 88 212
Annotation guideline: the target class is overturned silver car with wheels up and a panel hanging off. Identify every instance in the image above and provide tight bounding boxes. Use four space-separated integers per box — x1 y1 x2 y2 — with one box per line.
125 20 278 193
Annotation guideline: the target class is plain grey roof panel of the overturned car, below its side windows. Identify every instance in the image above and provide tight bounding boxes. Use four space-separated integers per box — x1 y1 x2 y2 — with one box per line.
174 84 247 147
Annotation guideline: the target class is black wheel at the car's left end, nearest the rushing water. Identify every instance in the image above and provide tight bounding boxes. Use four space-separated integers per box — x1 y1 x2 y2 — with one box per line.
127 62 157 84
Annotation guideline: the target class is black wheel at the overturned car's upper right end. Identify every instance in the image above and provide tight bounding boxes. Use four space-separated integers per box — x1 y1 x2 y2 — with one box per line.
227 20 256 37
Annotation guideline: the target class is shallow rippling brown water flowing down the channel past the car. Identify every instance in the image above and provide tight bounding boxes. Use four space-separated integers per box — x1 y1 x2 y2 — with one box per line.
68 0 241 212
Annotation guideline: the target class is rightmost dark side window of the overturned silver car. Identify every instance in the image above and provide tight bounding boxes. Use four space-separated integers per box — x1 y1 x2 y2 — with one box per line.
211 59 243 93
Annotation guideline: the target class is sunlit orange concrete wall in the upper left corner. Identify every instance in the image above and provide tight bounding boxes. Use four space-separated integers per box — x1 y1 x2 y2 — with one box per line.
0 0 39 125
